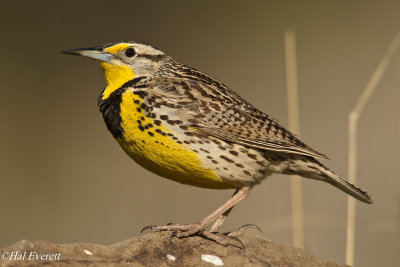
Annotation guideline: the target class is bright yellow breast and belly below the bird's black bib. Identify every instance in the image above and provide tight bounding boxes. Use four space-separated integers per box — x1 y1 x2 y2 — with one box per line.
117 90 232 189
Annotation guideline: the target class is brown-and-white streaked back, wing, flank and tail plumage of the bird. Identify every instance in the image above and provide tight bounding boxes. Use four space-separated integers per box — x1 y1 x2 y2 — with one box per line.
112 56 363 203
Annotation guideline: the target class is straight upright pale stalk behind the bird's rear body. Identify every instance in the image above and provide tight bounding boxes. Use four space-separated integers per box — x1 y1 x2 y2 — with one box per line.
285 30 304 248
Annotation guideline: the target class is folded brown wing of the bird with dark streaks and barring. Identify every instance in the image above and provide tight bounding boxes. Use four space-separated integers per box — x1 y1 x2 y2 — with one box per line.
147 71 327 159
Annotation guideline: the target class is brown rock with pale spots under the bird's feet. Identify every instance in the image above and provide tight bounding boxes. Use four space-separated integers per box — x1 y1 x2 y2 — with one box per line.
0 232 346 267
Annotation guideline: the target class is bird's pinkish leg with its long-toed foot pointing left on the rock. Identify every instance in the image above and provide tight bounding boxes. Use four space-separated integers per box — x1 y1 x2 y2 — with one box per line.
142 186 251 241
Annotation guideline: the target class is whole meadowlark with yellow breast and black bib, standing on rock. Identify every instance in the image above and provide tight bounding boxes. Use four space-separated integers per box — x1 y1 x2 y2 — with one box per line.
64 42 372 248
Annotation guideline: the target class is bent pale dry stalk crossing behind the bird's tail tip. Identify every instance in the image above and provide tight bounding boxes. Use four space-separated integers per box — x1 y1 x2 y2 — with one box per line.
346 32 400 265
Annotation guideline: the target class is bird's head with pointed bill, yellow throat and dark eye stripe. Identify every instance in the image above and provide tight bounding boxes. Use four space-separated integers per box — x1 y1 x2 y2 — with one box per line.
63 42 167 99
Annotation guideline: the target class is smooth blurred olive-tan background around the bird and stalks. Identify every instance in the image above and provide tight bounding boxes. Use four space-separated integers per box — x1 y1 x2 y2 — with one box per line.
0 0 400 266
